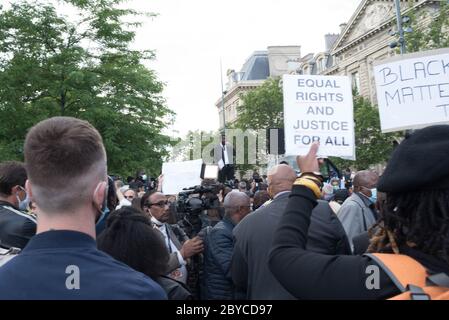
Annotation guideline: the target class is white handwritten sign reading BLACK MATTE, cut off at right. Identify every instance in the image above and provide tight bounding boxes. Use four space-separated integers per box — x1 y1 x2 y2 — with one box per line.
374 48 449 132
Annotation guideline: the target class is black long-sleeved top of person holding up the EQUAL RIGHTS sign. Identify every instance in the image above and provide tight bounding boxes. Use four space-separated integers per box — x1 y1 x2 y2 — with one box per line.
269 186 449 299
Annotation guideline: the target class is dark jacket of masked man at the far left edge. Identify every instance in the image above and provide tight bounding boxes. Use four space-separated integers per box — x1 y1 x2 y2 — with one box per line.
0 201 36 249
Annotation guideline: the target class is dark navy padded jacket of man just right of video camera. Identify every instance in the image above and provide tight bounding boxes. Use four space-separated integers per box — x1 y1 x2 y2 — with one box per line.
201 216 234 300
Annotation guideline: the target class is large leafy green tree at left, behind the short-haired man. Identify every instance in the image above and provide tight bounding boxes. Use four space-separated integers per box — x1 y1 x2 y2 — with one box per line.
0 0 173 175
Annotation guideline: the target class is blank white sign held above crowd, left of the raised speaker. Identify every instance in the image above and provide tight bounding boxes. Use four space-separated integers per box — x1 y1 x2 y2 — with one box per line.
162 159 203 194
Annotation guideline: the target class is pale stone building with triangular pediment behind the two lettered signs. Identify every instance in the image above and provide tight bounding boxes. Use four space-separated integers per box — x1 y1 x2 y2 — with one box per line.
298 0 440 104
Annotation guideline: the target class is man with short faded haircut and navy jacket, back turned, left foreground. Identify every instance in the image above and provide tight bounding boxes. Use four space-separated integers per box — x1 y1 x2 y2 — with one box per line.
0 117 166 300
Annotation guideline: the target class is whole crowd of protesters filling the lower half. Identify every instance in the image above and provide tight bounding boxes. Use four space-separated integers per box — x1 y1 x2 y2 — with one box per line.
0 117 449 300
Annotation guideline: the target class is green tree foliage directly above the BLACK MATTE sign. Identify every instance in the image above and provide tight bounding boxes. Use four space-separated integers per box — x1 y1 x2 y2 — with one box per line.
405 1 449 52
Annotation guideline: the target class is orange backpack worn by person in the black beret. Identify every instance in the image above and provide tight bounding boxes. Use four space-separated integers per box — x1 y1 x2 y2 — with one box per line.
365 253 449 300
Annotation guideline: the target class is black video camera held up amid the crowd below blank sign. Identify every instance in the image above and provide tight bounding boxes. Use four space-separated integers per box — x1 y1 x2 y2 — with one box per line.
176 184 219 215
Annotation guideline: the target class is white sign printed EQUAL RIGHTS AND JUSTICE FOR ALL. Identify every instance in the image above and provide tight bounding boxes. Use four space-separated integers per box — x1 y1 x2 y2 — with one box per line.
283 75 355 159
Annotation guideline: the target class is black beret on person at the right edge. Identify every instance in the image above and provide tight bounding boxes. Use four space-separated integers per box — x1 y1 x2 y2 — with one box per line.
377 125 449 193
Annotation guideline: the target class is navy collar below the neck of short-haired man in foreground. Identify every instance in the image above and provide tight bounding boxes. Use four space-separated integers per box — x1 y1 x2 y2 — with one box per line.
23 230 97 252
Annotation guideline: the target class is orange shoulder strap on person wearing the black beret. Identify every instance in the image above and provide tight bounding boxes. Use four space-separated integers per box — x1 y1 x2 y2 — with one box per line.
366 253 427 292
